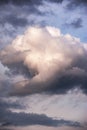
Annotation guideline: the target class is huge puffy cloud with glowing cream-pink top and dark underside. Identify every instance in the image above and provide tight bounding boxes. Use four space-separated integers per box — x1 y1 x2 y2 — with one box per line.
0 27 87 95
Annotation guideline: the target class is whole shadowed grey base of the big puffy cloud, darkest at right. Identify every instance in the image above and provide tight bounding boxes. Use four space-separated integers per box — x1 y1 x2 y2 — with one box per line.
10 69 87 96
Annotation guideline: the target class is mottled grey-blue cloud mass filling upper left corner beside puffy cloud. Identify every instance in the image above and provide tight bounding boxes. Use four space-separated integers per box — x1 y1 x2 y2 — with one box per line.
0 0 44 48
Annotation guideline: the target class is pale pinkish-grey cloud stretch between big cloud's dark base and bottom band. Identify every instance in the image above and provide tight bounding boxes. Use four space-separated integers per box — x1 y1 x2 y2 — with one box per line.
11 89 87 123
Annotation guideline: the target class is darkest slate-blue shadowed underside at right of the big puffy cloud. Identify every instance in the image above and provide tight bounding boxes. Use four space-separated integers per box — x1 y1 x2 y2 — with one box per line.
47 70 87 94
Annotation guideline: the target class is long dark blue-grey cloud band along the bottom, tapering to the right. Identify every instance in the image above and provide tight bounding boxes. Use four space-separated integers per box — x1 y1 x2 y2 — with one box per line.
0 101 82 128
